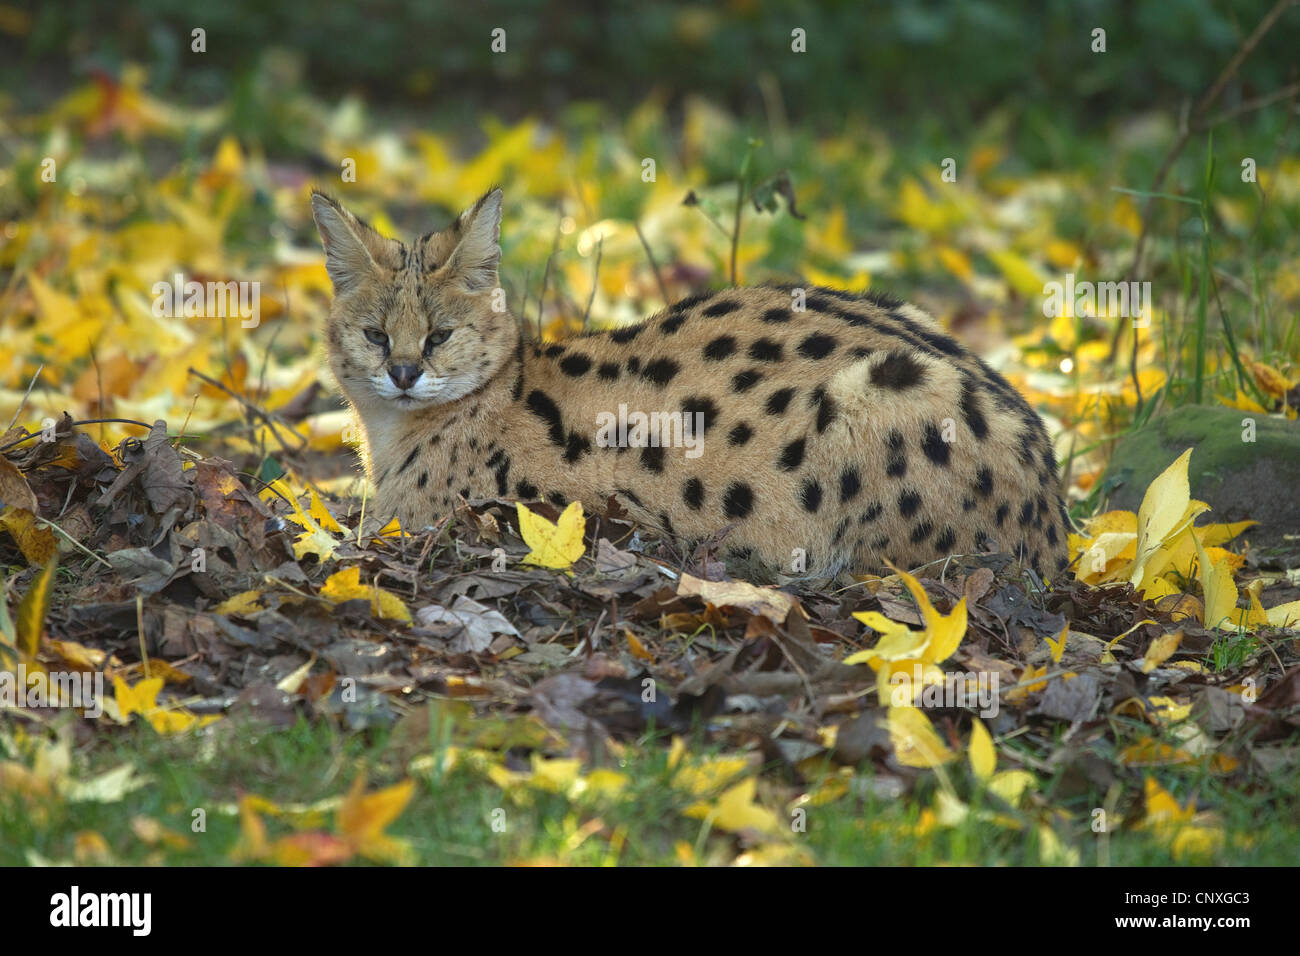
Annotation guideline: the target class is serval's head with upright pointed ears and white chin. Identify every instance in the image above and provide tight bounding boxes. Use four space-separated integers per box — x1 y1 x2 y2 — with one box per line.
312 189 517 411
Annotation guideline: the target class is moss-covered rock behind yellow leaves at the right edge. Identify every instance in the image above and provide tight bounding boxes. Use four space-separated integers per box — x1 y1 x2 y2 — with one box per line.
1102 406 1300 551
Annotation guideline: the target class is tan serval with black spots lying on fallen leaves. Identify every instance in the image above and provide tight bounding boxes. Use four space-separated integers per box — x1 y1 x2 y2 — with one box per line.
312 190 1067 575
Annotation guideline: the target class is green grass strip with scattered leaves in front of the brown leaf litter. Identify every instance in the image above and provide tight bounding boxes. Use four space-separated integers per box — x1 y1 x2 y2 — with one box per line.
10 722 1300 865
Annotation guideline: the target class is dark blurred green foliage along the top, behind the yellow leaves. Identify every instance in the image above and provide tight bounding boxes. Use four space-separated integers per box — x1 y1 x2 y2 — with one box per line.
10 0 1295 133
